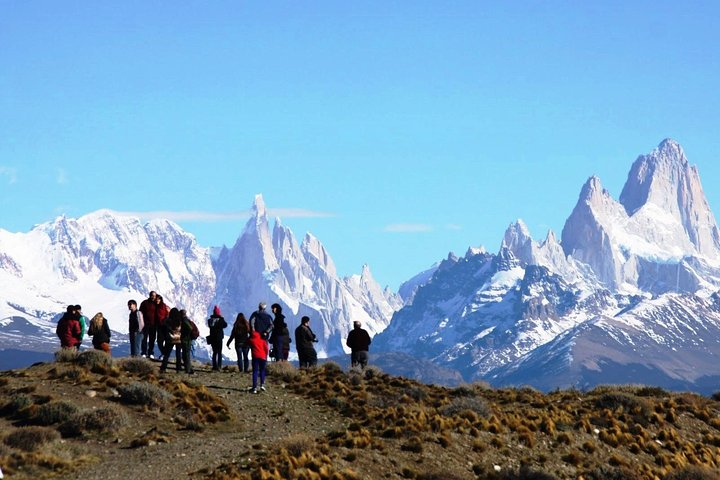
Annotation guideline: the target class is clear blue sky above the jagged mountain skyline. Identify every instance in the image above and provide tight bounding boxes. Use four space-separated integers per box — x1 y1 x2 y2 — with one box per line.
0 0 720 288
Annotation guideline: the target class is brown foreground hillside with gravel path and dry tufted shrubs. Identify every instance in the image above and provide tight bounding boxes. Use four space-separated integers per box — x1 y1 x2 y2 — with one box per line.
0 351 720 480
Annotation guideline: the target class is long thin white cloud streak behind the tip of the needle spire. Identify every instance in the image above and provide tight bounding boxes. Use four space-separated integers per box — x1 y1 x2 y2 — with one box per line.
115 208 335 223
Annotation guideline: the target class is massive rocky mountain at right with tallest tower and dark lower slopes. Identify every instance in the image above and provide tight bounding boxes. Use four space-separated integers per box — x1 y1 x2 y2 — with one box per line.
373 140 720 390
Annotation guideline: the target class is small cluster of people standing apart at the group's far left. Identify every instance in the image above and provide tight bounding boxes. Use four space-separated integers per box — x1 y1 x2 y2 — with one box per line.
55 305 111 354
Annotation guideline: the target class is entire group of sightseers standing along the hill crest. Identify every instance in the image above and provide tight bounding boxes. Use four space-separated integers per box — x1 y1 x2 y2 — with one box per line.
57 291 371 393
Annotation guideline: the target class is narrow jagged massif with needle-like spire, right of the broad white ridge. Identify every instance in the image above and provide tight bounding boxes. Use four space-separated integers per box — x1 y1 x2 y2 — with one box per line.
216 195 402 356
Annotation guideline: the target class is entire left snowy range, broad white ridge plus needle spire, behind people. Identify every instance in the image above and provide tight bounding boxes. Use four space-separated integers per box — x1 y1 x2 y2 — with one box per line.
0 196 401 369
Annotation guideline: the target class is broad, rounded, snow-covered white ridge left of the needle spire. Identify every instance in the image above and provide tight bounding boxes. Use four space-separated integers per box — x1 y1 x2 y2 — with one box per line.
0 210 215 360
